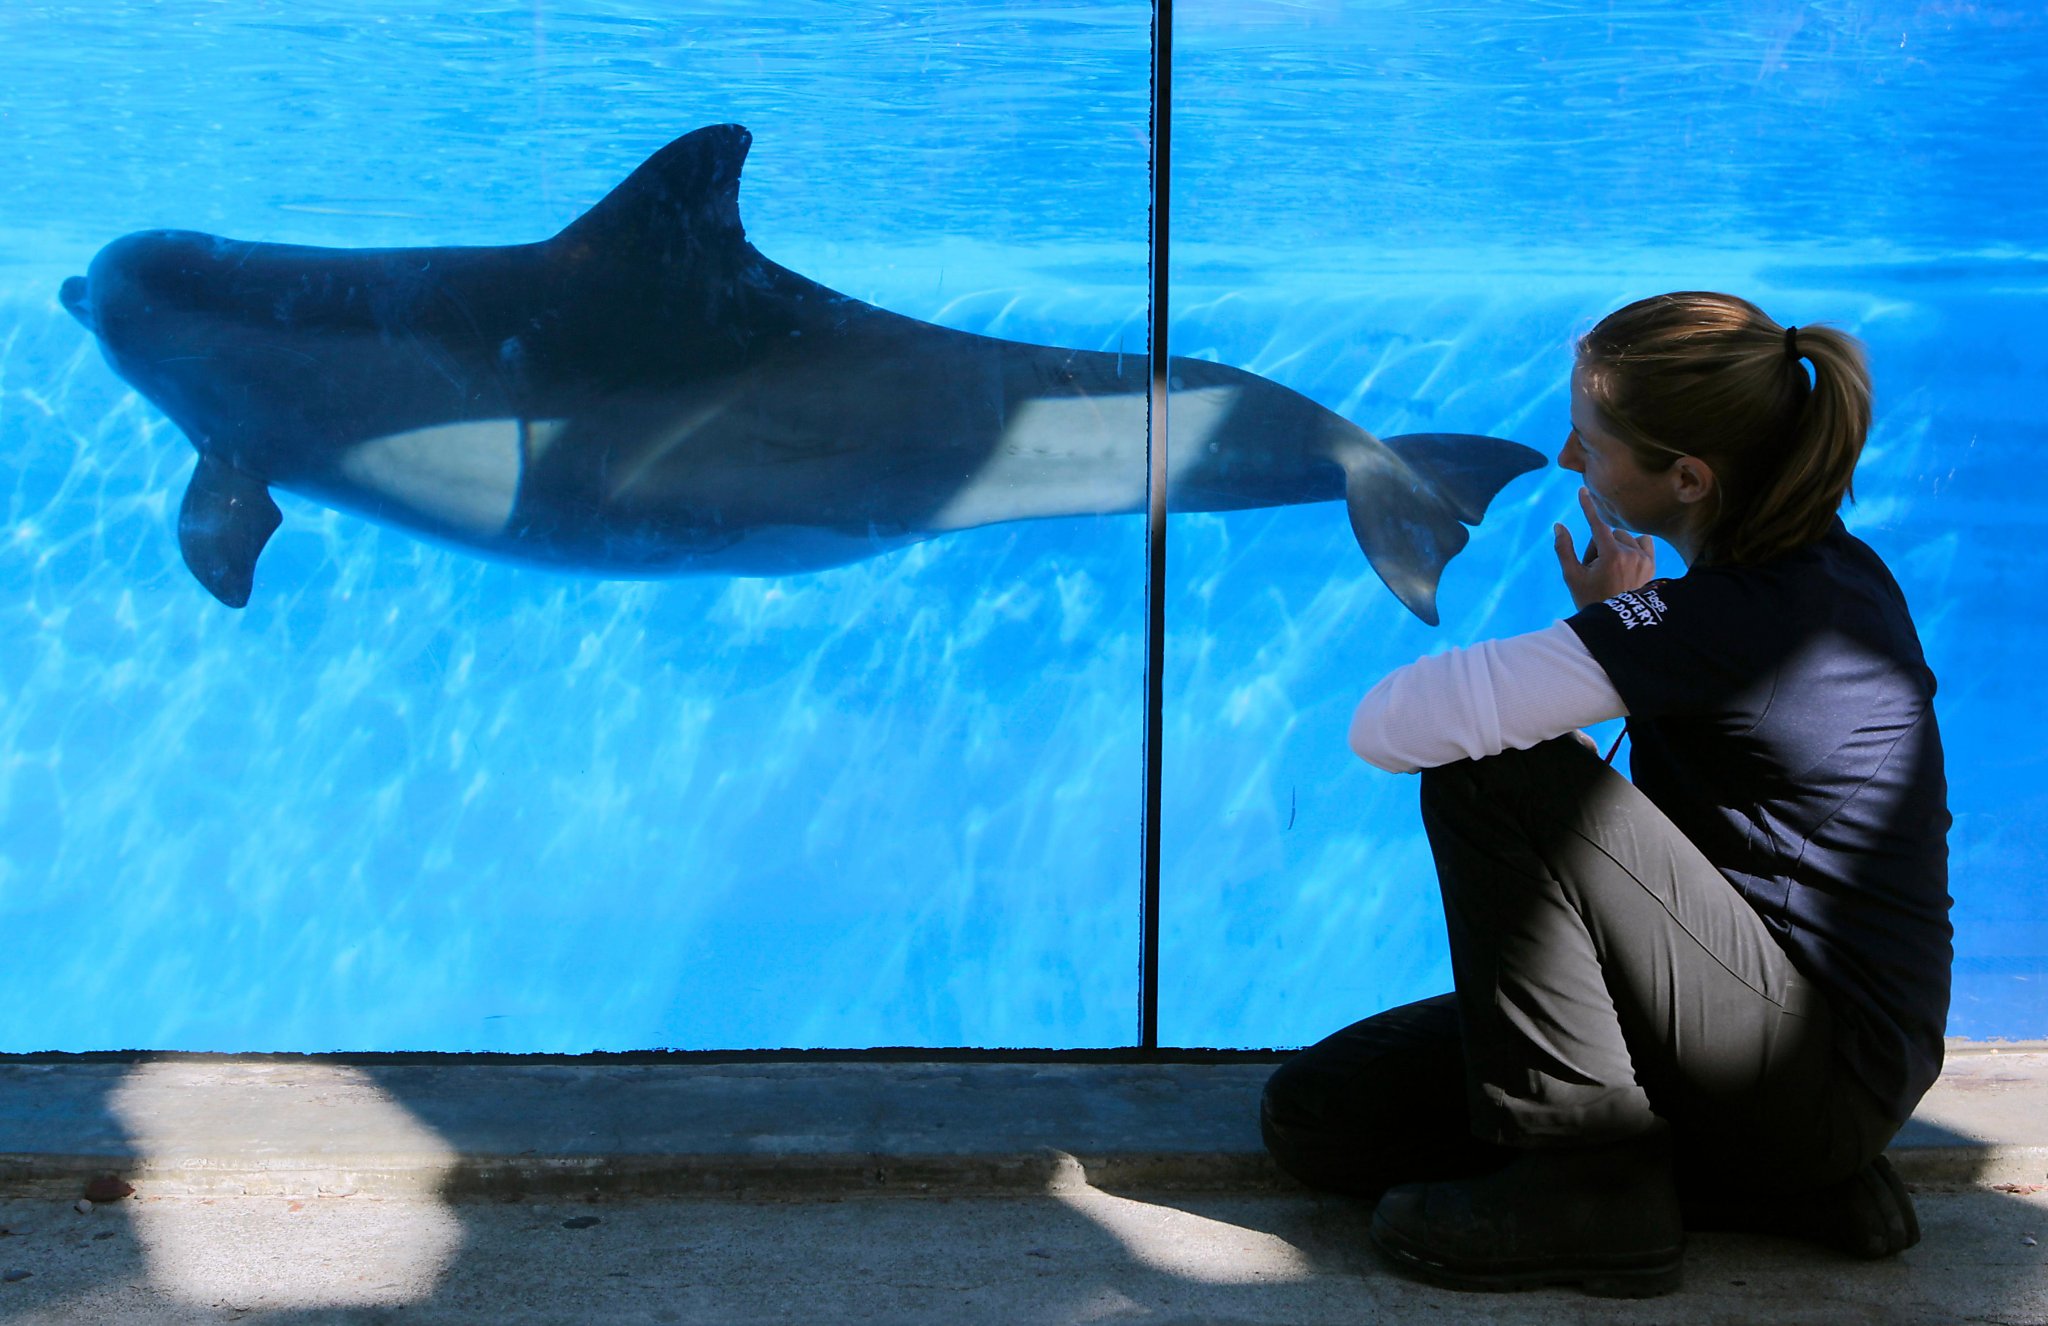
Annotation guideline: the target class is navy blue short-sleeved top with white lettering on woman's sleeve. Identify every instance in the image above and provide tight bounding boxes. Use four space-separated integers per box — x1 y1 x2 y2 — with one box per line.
1571 521 1952 1121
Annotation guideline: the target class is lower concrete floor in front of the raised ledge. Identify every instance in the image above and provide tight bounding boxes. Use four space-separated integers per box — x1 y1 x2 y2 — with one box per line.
0 1189 2048 1326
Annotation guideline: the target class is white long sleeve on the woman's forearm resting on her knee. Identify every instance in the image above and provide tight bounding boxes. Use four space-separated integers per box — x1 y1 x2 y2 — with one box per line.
1352 621 1628 773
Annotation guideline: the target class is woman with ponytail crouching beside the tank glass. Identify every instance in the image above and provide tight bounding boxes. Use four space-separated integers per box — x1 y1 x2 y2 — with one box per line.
1264 293 1950 1295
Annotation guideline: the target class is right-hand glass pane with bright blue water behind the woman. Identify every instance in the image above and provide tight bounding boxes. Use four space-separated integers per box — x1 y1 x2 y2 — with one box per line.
1159 0 2048 1045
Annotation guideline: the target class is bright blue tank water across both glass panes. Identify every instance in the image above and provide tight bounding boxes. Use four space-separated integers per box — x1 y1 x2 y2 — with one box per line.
0 0 2048 1051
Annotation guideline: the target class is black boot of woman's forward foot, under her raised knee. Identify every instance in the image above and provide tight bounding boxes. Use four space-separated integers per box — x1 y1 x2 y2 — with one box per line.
1372 1135 1686 1297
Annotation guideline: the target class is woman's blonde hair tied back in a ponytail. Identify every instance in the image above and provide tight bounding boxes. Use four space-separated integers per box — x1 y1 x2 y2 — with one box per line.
1577 291 1870 564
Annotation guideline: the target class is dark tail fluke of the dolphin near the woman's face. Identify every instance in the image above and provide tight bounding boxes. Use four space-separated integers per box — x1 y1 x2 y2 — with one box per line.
1343 432 1544 625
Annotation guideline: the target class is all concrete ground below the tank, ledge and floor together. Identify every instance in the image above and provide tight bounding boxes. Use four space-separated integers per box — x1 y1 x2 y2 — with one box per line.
0 1045 2048 1326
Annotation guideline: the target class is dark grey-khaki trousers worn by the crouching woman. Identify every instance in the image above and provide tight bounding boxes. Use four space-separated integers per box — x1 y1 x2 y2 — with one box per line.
1262 738 1901 1193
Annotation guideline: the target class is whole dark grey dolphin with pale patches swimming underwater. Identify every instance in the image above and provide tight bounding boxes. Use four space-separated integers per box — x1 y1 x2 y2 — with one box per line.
61 125 1542 623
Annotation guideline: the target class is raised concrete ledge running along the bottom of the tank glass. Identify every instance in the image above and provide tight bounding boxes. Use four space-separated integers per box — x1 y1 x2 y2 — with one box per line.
0 1045 2048 1199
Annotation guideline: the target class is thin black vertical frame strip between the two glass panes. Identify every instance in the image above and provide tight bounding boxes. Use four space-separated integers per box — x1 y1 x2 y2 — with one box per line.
1139 0 1174 1049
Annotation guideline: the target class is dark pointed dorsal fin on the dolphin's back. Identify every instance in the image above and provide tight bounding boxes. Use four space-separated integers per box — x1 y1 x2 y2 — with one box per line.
553 125 754 252
